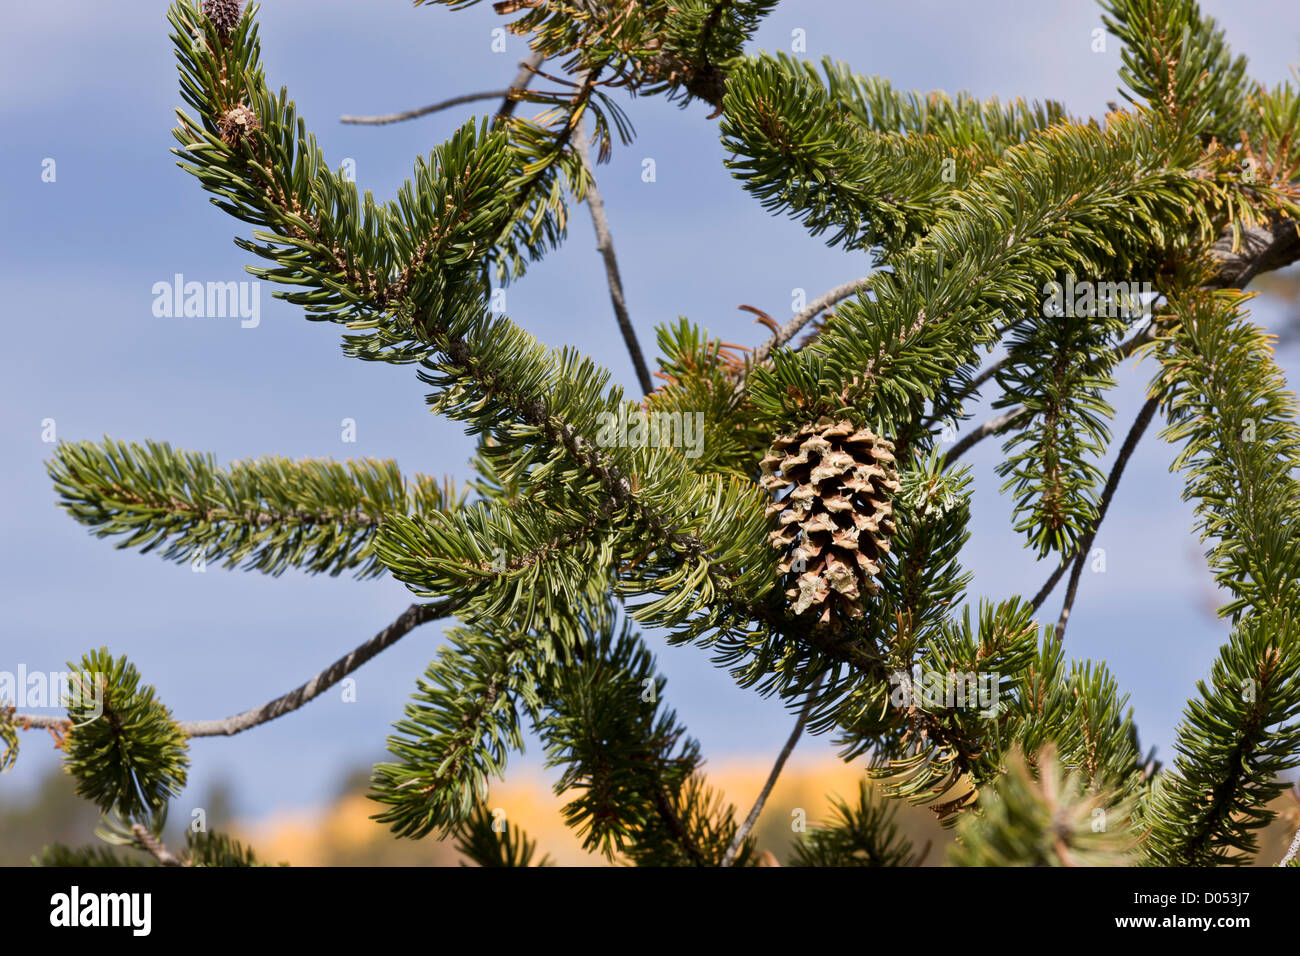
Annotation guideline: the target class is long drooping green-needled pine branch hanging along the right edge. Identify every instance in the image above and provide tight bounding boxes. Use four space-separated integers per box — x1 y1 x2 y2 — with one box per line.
1145 289 1300 866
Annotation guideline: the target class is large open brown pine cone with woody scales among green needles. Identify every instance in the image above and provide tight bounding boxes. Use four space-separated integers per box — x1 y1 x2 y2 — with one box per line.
761 418 901 624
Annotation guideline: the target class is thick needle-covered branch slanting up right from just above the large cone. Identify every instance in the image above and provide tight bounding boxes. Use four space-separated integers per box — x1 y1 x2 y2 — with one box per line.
750 110 1209 434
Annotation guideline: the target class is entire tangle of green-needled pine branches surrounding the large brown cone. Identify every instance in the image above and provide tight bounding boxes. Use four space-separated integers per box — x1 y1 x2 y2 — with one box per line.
68 0 1300 865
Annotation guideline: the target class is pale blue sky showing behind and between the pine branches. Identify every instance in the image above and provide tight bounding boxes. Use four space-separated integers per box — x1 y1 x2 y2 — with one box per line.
0 0 1300 814
